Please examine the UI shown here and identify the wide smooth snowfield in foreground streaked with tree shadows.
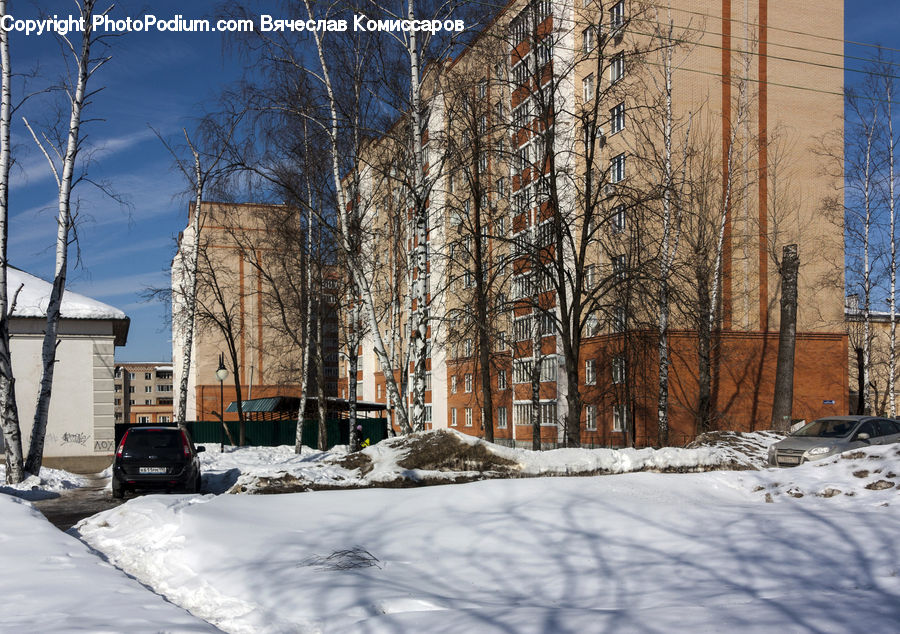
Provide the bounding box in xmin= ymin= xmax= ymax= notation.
xmin=73 ymin=445 xmax=900 ymax=633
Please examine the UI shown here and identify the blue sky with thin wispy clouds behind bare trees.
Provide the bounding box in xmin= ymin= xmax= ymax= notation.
xmin=10 ymin=0 xmax=900 ymax=361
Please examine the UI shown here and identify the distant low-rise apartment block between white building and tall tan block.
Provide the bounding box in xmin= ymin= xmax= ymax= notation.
xmin=113 ymin=361 xmax=174 ymax=423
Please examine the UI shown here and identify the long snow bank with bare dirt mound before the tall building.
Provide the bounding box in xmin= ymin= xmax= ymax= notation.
xmin=201 ymin=430 xmax=780 ymax=493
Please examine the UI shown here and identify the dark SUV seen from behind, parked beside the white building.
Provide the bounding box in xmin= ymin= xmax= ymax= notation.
xmin=112 ymin=425 xmax=206 ymax=498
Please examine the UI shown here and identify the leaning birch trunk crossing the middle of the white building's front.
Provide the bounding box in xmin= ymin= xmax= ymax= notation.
xmin=25 ymin=0 xmax=102 ymax=475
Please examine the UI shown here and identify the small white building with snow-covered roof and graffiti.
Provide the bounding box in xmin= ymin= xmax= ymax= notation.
xmin=0 ymin=268 xmax=129 ymax=471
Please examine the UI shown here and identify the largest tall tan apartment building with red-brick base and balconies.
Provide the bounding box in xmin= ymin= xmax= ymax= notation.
xmin=339 ymin=0 xmax=848 ymax=446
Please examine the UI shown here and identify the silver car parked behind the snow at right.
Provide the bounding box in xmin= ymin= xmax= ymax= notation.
xmin=769 ymin=416 xmax=900 ymax=467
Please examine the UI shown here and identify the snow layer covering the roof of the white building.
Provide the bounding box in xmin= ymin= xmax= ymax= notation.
xmin=6 ymin=267 xmax=126 ymax=319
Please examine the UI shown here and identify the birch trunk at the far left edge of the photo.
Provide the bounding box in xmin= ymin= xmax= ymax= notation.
xmin=0 ymin=0 xmax=25 ymax=484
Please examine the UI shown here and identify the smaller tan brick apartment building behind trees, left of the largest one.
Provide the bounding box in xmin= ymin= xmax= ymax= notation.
xmin=172 ymin=202 xmax=338 ymax=420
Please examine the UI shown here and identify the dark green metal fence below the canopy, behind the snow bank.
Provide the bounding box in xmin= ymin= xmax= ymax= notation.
xmin=187 ymin=418 xmax=387 ymax=449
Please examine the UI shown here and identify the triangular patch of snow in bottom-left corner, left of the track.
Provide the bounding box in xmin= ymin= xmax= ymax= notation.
xmin=0 ymin=495 xmax=213 ymax=634
